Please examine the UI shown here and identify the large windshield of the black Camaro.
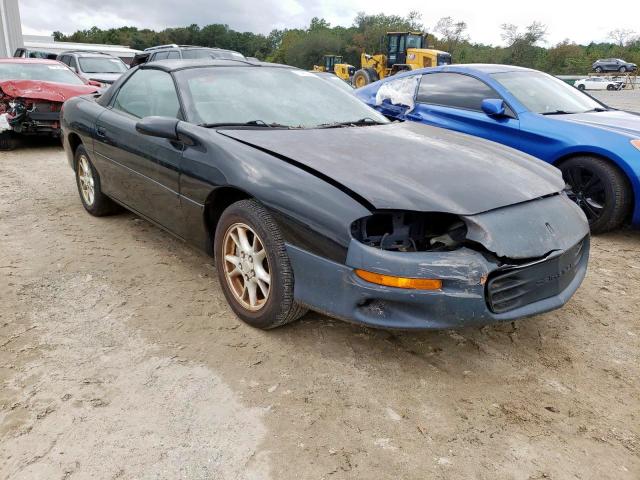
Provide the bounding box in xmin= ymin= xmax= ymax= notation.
xmin=175 ymin=67 xmax=388 ymax=128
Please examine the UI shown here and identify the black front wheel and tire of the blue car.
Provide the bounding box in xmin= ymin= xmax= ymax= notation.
xmin=560 ymin=156 xmax=632 ymax=234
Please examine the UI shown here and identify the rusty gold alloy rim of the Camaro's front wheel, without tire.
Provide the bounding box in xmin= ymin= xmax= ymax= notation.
xmin=222 ymin=223 xmax=271 ymax=312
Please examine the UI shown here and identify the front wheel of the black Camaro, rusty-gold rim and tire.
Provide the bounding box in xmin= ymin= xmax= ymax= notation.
xmin=214 ymin=200 xmax=306 ymax=330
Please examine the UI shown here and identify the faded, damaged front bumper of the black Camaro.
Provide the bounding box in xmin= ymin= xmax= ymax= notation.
xmin=287 ymin=196 xmax=589 ymax=329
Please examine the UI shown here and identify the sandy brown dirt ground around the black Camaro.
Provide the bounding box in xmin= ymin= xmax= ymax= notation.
xmin=0 ymin=92 xmax=640 ymax=480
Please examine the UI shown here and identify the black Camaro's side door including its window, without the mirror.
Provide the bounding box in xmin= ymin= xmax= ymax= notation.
xmin=94 ymin=68 xmax=183 ymax=235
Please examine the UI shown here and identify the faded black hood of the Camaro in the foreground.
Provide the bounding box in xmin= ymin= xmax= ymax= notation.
xmin=218 ymin=122 xmax=564 ymax=215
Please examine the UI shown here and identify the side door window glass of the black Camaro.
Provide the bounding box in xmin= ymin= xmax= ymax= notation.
xmin=113 ymin=69 xmax=181 ymax=118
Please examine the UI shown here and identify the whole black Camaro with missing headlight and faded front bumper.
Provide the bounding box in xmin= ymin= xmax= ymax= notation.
xmin=62 ymin=60 xmax=589 ymax=329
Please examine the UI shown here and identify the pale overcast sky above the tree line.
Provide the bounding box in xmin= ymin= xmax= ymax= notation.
xmin=19 ymin=0 xmax=640 ymax=45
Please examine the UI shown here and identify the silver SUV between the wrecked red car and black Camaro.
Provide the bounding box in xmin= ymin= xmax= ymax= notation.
xmin=57 ymin=50 xmax=129 ymax=85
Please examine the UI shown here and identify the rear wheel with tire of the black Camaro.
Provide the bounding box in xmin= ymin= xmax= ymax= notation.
xmin=74 ymin=145 xmax=119 ymax=217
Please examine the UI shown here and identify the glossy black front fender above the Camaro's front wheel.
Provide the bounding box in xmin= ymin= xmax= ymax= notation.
xmin=180 ymin=124 xmax=370 ymax=263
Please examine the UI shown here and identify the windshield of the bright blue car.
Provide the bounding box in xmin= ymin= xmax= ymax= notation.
xmin=492 ymin=71 xmax=603 ymax=114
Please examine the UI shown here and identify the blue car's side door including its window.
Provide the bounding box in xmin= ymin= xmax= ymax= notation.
xmin=406 ymin=72 xmax=521 ymax=148
